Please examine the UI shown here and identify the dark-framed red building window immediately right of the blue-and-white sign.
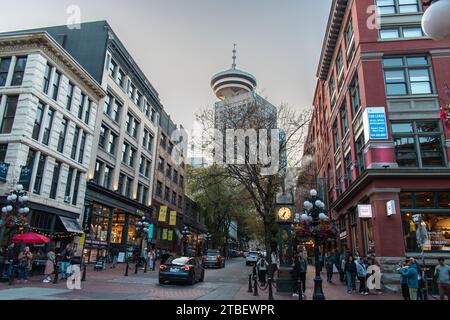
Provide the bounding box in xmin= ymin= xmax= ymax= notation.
xmin=392 ymin=121 xmax=445 ymax=167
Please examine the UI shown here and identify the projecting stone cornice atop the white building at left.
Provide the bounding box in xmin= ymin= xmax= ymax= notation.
xmin=0 ymin=32 xmax=106 ymax=101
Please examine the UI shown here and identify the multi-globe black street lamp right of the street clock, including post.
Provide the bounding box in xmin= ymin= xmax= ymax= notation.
xmin=301 ymin=189 xmax=330 ymax=300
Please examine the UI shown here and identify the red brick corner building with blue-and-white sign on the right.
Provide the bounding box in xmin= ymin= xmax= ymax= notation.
xmin=300 ymin=0 xmax=450 ymax=290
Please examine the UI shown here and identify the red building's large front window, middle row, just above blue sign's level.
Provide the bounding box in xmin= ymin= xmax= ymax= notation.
xmin=383 ymin=56 xmax=433 ymax=96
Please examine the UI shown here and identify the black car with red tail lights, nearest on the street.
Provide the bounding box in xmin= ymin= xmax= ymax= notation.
xmin=159 ymin=257 xmax=205 ymax=285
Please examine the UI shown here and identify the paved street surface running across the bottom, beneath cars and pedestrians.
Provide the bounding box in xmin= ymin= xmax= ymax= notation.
xmin=0 ymin=258 xmax=408 ymax=300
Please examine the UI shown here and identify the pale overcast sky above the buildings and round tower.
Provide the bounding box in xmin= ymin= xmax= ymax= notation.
xmin=0 ymin=0 xmax=331 ymax=129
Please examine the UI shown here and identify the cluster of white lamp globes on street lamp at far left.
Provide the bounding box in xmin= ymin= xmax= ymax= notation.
xmin=1 ymin=184 xmax=30 ymax=242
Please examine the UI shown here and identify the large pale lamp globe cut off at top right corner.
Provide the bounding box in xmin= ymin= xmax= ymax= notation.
xmin=422 ymin=0 xmax=450 ymax=40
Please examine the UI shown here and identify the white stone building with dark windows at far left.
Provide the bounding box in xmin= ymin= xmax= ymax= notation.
xmin=0 ymin=32 xmax=105 ymax=251
